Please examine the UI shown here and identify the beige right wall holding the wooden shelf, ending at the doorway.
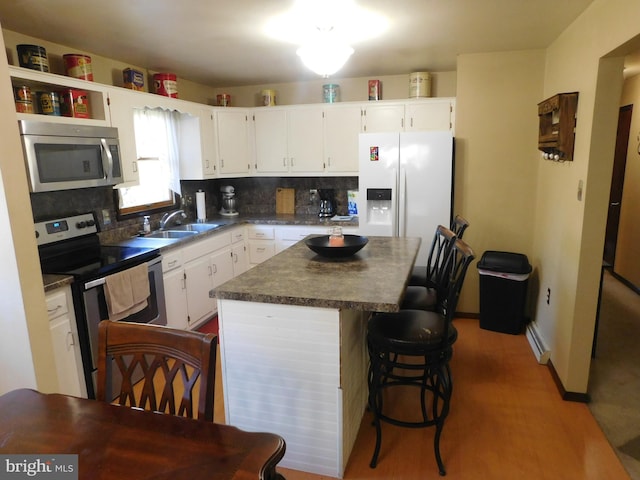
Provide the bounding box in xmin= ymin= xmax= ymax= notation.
xmin=534 ymin=0 xmax=640 ymax=392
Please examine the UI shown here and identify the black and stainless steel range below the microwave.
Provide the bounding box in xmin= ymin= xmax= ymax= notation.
xmin=35 ymin=213 xmax=167 ymax=398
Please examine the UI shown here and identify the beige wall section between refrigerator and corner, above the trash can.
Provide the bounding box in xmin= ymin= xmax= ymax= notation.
xmin=455 ymin=50 xmax=545 ymax=312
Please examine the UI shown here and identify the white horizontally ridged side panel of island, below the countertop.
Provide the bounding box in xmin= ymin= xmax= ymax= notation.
xmin=218 ymin=299 xmax=350 ymax=478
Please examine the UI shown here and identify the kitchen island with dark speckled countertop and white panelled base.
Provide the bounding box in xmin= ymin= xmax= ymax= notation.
xmin=215 ymin=237 xmax=420 ymax=478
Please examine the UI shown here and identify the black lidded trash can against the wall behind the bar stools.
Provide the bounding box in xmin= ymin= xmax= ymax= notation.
xmin=477 ymin=250 xmax=531 ymax=335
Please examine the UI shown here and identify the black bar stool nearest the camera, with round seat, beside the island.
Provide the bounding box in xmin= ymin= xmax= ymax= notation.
xmin=367 ymin=240 xmax=474 ymax=475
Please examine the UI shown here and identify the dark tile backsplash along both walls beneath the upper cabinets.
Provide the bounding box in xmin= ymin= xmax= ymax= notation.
xmin=31 ymin=177 xmax=358 ymax=241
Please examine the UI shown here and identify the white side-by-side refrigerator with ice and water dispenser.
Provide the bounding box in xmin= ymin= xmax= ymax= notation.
xmin=358 ymin=131 xmax=453 ymax=265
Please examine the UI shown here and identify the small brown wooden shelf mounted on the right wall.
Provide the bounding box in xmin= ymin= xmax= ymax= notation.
xmin=538 ymin=92 xmax=578 ymax=162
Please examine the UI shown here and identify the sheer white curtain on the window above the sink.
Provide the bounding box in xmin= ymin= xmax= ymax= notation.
xmin=134 ymin=108 xmax=182 ymax=194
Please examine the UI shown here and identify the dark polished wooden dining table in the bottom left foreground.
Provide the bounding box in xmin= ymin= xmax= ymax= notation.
xmin=0 ymin=389 xmax=285 ymax=480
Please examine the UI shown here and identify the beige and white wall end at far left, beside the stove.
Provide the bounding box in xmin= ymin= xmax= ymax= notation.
xmin=0 ymin=25 xmax=58 ymax=394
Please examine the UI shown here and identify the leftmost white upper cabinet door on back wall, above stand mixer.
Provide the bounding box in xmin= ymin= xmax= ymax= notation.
xmin=215 ymin=108 xmax=251 ymax=176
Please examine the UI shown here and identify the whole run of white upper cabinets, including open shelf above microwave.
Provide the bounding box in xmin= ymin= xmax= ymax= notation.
xmin=9 ymin=66 xmax=455 ymax=182
